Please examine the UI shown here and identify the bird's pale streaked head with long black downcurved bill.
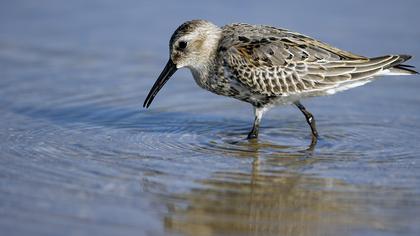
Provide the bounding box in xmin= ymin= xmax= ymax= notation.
xmin=143 ymin=20 xmax=221 ymax=108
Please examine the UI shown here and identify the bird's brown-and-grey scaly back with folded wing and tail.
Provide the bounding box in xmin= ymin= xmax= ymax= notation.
xmin=218 ymin=24 xmax=416 ymax=106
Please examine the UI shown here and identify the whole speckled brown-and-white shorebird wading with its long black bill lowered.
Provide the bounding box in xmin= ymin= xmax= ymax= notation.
xmin=143 ymin=20 xmax=418 ymax=144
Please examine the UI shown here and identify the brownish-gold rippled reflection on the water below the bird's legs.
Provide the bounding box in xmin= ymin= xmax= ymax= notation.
xmin=164 ymin=138 xmax=386 ymax=235
